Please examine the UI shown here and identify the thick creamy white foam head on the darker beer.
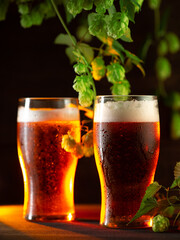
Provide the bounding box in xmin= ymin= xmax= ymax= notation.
xmin=94 ymin=100 xmax=159 ymax=122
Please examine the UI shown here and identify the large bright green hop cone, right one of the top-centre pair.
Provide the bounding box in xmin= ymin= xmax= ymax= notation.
xmin=106 ymin=12 xmax=129 ymax=39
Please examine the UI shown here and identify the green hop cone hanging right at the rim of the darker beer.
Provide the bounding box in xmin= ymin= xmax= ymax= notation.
xmin=111 ymin=80 xmax=131 ymax=95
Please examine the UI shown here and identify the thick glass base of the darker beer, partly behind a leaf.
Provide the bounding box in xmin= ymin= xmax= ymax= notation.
xmin=101 ymin=216 xmax=151 ymax=229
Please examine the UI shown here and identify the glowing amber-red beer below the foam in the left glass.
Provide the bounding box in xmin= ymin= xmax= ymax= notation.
xmin=17 ymin=121 xmax=80 ymax=221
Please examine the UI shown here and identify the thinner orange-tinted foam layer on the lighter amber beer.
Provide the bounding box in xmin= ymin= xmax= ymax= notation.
xmin=17 ymin=107 xmax=79 ymax=122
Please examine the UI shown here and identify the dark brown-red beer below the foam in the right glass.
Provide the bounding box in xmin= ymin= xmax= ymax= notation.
xmin=94 ymin=122 xmax=160 ymax=227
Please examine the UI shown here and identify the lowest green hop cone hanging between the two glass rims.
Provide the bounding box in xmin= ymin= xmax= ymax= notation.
xmin=78 ymin=88 xmax=94 ymax=107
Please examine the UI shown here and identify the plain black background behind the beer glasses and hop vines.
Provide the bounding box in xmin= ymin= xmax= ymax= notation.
xmin=0 ymin=0 xmax=180 ymax=204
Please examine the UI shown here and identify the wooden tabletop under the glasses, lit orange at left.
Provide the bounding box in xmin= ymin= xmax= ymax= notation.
xmin=0 ymin=205 xmax=180 ymax=240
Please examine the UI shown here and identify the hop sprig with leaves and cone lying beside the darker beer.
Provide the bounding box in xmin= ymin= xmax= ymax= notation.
xmin=129 ymin=165 xmax=180 ymax=232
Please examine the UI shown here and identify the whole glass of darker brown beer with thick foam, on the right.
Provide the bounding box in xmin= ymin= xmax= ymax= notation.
xmin=94 ymin=96 xmax=160 ymax=228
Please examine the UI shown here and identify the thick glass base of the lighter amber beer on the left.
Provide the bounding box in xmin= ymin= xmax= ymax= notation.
xmin=24 ymin=213 xmax=75 ymax=222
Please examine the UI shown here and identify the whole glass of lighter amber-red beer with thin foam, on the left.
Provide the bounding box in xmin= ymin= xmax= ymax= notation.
xmin=17 ymin=98 xmax=80 ymax=222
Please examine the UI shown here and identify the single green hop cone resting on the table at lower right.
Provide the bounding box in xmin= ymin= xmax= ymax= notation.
xmin=152 ymin=214 xmax=170 ymax=232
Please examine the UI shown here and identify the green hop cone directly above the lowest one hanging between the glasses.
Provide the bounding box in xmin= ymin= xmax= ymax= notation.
xmin=73 ymin=75 xmax=91 ymax=92
